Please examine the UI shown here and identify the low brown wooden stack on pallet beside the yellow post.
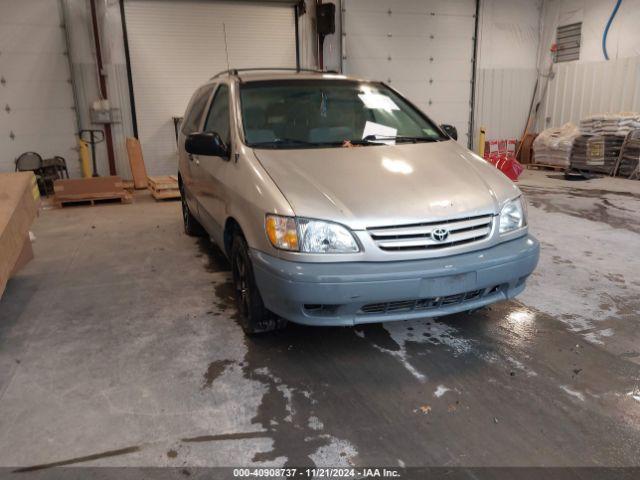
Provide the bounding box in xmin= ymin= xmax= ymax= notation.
xmin=53 ymin=176 xmax=131 ymax=207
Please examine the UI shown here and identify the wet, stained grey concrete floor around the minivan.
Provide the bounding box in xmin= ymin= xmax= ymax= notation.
xmin=0 ymin=172 xmax=640 ymax=467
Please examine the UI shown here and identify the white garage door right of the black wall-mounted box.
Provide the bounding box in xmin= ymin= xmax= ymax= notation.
xmin=343 ymin=0 xmax=475 ymax=145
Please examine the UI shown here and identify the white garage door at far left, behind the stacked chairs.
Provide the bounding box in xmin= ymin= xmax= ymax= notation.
xmin=0 ymin=0 xmax=79 ymax=174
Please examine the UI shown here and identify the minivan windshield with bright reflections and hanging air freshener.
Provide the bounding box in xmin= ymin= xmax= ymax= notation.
xmin=240 ymin=80 xmax=447 ymax=148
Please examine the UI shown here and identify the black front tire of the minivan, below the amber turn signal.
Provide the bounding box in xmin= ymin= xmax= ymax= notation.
xmin=231 ymin=232 xmax=285 ymax=335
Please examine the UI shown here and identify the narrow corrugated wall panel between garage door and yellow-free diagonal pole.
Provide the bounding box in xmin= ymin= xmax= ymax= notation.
xmin=473 ymin=68 xmax=537 ymax=149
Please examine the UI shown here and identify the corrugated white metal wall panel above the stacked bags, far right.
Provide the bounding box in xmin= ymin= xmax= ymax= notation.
xmin=538 ymin=57 xmax=640 ymax=130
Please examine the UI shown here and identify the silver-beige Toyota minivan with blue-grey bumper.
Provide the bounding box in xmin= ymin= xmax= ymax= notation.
xmin=178 ymin=69 xmax=539 ymax=334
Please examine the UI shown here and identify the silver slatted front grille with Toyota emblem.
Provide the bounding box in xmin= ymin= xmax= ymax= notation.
xmin=367 ymin=215 xmax=493 ymax=251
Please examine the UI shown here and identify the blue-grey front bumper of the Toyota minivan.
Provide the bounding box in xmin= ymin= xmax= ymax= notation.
xmin=251 ymin=235 xmax=540 ymax=326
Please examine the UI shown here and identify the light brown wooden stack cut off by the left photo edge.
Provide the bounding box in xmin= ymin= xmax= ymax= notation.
xmin=0 ymin=172 xmax=40 ymax=297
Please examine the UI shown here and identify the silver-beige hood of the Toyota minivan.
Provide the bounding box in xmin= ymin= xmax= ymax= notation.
xmin=254 ymin=141 xmax=519 ymax=230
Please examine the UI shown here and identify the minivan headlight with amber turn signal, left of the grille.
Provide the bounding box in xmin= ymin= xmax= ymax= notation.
xmin=265 ymin=215 xmax=360 ymax=253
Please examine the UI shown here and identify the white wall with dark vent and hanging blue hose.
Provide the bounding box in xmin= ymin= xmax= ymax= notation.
xmin=537 ymin=0 xmax=640 ymax=130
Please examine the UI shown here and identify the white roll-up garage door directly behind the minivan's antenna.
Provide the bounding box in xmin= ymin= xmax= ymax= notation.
xmin=125 ymin=0 xmax=296 ymax=175
